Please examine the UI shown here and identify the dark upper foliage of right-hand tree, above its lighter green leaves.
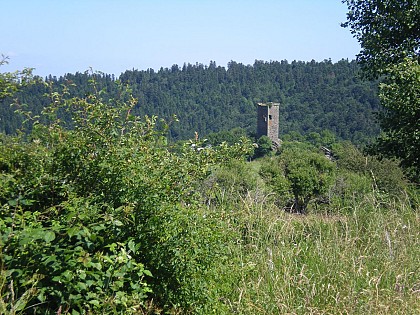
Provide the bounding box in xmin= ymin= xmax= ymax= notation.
xmin=343 ymin=0 xmax=420 ymax=77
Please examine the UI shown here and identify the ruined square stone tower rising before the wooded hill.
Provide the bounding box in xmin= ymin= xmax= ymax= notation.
xmin=257 ymin=102 xmax=280 ymax=145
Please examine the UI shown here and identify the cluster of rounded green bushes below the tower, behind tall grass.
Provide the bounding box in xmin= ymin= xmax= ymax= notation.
xmin=256 ymin=141 xmax=408 ymax=215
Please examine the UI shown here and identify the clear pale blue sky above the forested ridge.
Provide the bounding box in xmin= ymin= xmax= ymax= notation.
xmin=0 ymin=0 xmax=360 ymax=77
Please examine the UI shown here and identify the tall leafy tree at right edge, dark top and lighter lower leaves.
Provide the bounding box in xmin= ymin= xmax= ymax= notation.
xmin=343 ymin=0 xmax=420 ymax=182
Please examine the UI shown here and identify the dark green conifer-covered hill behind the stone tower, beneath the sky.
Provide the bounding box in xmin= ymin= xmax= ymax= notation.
xmin=0 ymin=60 xmax=379 ymax=143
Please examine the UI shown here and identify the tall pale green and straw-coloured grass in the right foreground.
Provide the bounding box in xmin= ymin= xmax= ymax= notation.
xmin=220 ymin=193 xmax=420 ymax=314
